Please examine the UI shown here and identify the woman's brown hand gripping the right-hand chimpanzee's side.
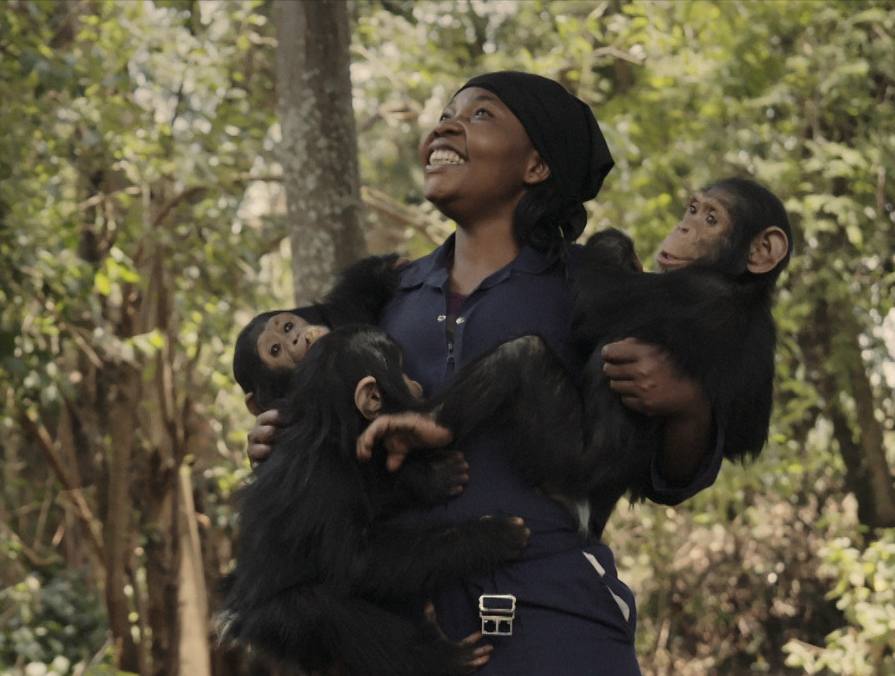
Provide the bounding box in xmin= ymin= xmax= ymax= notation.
xmin=601 ymin=338 xmax=708 ymax=416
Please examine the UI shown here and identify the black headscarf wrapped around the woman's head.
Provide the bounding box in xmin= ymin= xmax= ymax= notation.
xmin=458 ymin=70 xmax=615 ymax=204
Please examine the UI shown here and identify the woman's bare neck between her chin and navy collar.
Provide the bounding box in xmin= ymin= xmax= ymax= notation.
xmin=450 ymin=221 xmax=519 ymax=296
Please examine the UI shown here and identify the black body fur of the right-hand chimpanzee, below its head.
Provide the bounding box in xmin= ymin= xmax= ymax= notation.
xmin=574 ymin=223 xmax=788 ymax=533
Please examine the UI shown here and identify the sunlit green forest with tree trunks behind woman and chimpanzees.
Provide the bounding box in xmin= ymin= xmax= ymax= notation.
xmin=0 ymin=0 xmax=895 ymax=676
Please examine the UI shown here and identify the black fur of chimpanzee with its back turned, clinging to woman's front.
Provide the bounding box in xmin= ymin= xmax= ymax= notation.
xmin=224 ymin=327 xmax=527 ymax=676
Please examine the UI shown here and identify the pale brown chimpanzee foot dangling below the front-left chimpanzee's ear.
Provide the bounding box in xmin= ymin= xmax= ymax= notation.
xmin=357 ymin=413 xmax=454 ymax=472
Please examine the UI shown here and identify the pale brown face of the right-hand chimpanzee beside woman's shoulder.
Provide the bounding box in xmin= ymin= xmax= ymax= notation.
xmin=656 ymin=192 xmax=733 ymax=272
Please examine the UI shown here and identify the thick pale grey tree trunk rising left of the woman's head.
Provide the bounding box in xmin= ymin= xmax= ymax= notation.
xmin=274 ymin=0 xmax=366 ymax=305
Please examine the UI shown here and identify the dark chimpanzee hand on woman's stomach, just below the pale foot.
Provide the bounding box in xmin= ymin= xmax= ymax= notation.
xmin=397 ymin=451 xmax=469 ymax=505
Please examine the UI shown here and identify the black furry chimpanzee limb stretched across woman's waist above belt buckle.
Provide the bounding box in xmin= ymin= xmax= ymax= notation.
xmin=353 ymin=516 xmax=529 ymax=600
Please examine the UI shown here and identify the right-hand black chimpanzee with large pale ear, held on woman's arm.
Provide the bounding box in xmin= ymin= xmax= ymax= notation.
xmin=575 ymin=178 xmax=792 ymax=533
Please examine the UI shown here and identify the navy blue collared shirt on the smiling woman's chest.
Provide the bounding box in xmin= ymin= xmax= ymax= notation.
xmin=380 ymin=235 xmax=723 ymax=505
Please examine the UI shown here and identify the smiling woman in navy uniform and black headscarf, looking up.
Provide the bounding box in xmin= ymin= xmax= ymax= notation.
xmin=250 ymin=72 xmax=721 ymax=676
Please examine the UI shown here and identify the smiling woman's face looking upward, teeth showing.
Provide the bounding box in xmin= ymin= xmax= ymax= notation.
xmin=420 ymin=87 xmax=546 ymax=220
